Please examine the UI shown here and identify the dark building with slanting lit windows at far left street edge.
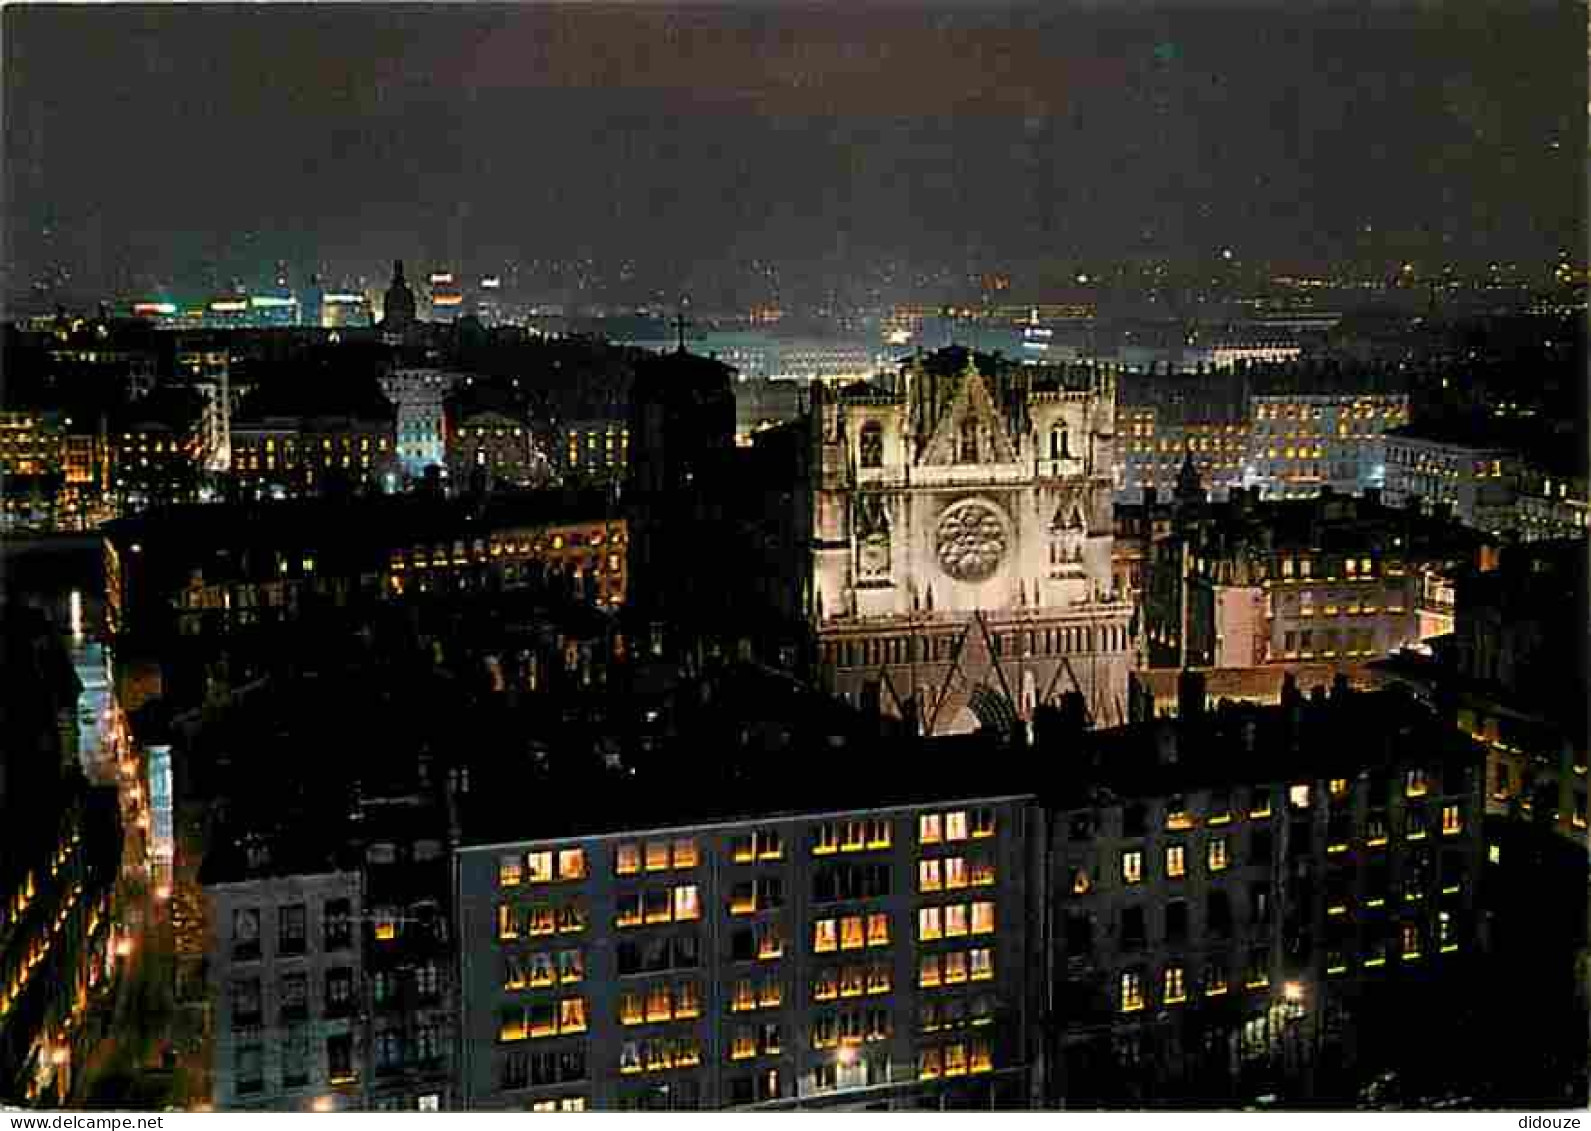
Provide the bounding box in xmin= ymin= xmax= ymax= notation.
xmin=0 ymin=603 xmax=121 ymax=1107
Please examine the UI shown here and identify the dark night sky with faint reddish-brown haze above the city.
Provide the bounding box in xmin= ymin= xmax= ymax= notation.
xmin=3 ymin=0 xmax=1588 ymax=299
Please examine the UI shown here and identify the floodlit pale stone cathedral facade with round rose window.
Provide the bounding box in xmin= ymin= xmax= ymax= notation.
xmin=802 ymin=350 xmax=1133 ymax=733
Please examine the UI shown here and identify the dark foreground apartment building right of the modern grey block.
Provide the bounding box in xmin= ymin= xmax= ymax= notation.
xmin=1039 ymin=673 xmax=1484 ymax=1107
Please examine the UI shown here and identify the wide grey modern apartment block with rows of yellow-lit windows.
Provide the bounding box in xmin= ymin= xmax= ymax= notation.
xmin=455 ymin=740 xmax=1041 ymax=1112
